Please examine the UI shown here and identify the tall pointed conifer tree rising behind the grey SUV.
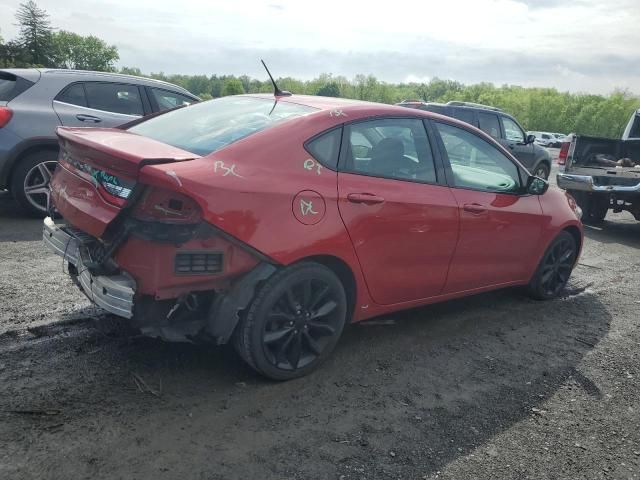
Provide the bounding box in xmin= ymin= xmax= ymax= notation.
xmin=16 ymin=0 xmax=52 ymax=66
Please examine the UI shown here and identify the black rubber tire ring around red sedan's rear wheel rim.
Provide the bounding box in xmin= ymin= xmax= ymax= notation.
xmin=243 ymin=262 xmax=347 ymax=380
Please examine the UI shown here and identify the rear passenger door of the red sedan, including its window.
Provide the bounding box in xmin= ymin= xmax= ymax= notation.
xmin=338 ymin=118 xmax=458 ymax=305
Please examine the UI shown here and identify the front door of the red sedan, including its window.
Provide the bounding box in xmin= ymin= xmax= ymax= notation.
xmin=434 ymin=121 xmax=543 ymax=293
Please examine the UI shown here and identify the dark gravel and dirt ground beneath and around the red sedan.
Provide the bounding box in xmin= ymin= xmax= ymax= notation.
xmin=0 ymin=173 xmax=640 ymax=480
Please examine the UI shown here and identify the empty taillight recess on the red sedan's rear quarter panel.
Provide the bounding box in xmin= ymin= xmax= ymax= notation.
xmin=133 ymin=187 xmax=202 ymax=224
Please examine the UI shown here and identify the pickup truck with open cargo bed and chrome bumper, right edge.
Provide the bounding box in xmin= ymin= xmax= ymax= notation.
xmin=557 ymin=109 xmax=640 ymax=223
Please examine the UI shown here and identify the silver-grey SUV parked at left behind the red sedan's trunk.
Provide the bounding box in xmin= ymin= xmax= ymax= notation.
xmin=0 ymin=68 xmax=199 ymax=215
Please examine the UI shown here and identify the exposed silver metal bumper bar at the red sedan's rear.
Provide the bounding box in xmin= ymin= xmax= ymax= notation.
xmin=42 ymin=217 xmax=136 ymax=318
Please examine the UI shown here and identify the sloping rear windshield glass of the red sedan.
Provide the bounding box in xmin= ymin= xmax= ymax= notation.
xmin=129 ymin=97 xmax=317 ymax=156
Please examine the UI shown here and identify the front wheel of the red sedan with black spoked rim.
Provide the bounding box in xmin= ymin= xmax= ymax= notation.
xmin=528 ymin=231 xmax=578 ymax=300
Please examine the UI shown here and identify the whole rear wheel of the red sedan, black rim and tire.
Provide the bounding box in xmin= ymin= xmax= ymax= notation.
xmin=234 ymin=262 xmax=347 ymax=380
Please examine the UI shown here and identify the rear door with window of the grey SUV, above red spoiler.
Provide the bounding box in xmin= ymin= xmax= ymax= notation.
xmin=53 ymin=82 xmax=145 ymax=127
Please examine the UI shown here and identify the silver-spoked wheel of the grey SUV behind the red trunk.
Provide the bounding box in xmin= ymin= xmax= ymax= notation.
xmin=11 ymin=150 xmax=58 ymax=217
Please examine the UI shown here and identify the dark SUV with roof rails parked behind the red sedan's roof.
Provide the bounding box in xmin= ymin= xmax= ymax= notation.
xmin=397 ymin=100 xmax=551 ymax=179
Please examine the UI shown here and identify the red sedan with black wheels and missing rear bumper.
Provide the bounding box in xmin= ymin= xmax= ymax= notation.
xmin=43 ymin=95 xmax=583 ymax=380
